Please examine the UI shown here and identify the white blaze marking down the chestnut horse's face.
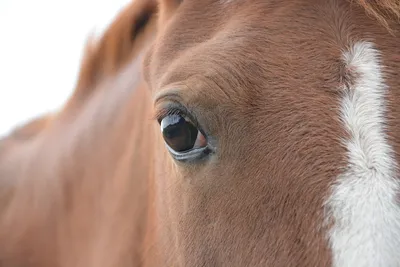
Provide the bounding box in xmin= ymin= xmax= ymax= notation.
xmin=326 ymin=42 xmax=400 ymax=267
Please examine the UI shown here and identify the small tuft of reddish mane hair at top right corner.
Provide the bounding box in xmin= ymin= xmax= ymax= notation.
xmin=354 ymin=0 xmax=400 ymax=32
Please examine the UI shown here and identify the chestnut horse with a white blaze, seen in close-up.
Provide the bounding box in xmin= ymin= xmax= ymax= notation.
xmin=0 ymin=0 xmax=400 ymax=267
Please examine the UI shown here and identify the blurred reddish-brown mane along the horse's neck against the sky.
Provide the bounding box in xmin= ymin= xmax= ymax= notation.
xmin=71 ymin=0 xmax=158 ymax=104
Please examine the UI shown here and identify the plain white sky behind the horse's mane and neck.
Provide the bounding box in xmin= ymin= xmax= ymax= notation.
xmin=0 ymin=0 xmax=130 ymax=136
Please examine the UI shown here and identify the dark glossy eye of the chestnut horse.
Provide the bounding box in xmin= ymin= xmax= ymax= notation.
xmin=161 ymin=114 xmax=207 ymax=153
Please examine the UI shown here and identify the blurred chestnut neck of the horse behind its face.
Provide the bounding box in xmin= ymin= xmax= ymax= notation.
xmin=0 ymin=57 xmax=159 ymax=267
